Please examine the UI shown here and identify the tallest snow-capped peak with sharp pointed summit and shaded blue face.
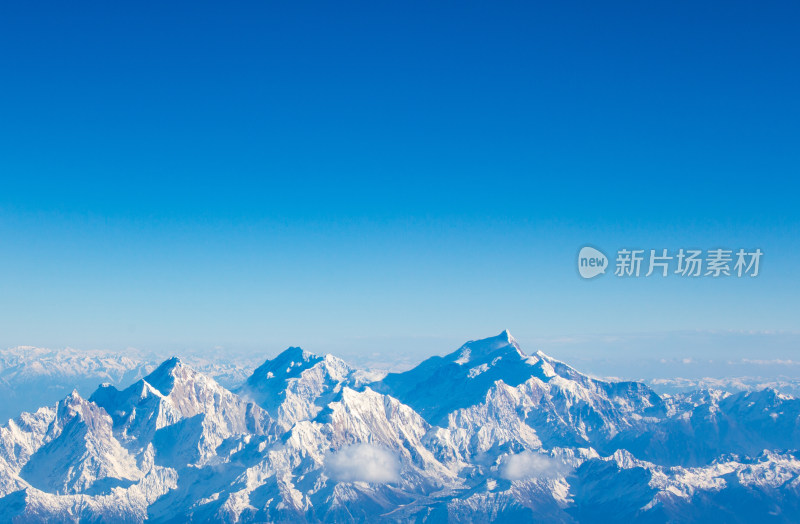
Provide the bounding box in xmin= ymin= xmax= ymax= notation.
xmin=372 ymin=331 xmax=666 ymax=446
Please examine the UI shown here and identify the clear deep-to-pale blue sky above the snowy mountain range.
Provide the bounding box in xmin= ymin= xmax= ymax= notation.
xmin=0 ymin=2 xmax=800 ymax=374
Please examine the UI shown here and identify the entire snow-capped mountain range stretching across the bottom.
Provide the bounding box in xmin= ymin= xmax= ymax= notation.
xmin=0 ymin=332 xmax=800 ymax=522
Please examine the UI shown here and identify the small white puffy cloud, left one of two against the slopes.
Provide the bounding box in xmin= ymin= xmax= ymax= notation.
xmin=325 ymin=444 xmax=400 ymax=484
